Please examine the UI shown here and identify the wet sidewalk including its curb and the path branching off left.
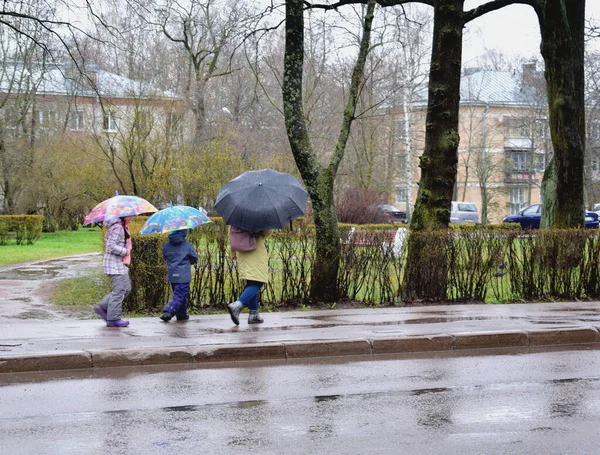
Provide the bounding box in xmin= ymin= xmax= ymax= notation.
xmin=0 ymin=255 xmax=600 ymax=372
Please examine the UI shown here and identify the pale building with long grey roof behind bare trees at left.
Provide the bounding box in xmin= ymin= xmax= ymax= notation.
xmin=0 ymin=62 xmax=186 ymax=145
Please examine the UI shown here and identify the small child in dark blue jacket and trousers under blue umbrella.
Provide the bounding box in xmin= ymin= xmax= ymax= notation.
xmin=160 ymin=229 xmax=198 ymax=322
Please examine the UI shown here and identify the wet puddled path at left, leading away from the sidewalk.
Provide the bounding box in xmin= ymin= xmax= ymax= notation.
xmin=0 ymin=253 xmax=102 ymax=320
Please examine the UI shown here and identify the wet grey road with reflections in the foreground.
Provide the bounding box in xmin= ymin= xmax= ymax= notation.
xmin=0 ymin=346 xmax=600 ymax=455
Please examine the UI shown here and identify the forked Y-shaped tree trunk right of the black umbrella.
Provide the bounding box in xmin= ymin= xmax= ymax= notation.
xmin=283 ymin=0 xmax=375 ymax=302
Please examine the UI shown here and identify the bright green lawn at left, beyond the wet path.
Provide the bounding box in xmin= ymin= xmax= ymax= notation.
xmin=0 ymin=228 xmax=102 ymax=266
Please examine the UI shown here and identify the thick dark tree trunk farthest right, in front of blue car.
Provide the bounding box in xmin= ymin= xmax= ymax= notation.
xmin=537 ymin=0 xmax=585 ymax=228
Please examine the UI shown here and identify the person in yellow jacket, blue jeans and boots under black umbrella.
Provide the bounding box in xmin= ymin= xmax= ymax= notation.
xmin=227 ymin=231 xmax=270 ymax=325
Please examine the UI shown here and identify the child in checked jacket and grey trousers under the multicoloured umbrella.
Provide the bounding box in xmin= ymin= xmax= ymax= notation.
xmin=94 ymin=216 xmax=131 ymax=327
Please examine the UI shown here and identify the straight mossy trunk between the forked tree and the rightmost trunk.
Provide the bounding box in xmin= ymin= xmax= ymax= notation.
xmin=405 ymin=0 xmax=464 ymax=300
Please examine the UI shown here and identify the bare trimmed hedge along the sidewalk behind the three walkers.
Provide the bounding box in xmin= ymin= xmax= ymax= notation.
xmin=126 ymin=219 xmax=600 ymax=311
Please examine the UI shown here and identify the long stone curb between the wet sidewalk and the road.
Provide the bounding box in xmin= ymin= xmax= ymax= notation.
xmin=0 ymin=327 xmax=600 ymax=374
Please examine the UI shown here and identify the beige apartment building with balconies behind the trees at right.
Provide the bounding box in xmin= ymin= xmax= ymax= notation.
xmin=388 ymin=63 xmax=551 ymax=223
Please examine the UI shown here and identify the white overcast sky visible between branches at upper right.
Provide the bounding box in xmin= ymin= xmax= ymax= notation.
xmin=463 ymin=0 xmax=600 ymax=65
